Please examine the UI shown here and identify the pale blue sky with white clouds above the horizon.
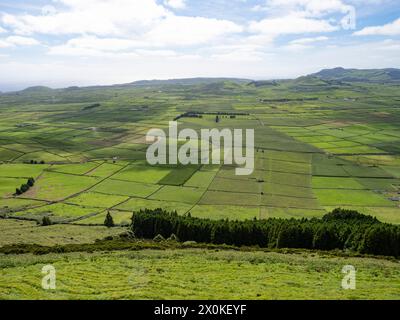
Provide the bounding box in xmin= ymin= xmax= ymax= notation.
xmin=0 ymin=0 xmax=400 ymax=91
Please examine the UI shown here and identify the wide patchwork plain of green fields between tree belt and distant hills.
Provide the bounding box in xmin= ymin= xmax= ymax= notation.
xmin=0 ymin=80 xmax=400 ymax=226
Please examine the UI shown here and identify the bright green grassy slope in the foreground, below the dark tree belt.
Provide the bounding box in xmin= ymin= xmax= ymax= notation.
xmin=0 ymin=249 xmax=400 ymax=299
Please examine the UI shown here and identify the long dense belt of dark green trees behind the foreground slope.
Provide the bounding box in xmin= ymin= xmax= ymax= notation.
xmin=132 ymin=209 xmax=400 ymax=256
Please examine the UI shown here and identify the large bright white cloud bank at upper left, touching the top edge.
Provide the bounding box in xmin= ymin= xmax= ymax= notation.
xmin=1 ymin=0 xmax=243 ymax=54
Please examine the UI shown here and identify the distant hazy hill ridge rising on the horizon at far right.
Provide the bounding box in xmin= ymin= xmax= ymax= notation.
xmin=308 ymin=67 xmax=400 ymax=82
